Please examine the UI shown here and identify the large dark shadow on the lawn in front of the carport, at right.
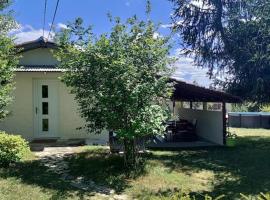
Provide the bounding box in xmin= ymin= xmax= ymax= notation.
xmin=144 ymin=137 xmax=270 ymax=199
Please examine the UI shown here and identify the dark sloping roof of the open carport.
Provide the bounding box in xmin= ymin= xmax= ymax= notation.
xmin=171 ymin=79 xmax=242 ymax=103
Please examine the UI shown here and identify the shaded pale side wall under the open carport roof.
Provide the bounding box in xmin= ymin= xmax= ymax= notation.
xmin=177 ymin=107 xmax=223 ymax=145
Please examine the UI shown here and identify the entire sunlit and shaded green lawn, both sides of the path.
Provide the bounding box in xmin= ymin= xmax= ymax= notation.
xmin=0 ymin=129 xmax=270 ymax=199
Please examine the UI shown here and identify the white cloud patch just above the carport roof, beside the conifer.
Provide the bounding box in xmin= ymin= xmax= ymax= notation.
xmin=172 ymin=49 xmax=212 ymax=87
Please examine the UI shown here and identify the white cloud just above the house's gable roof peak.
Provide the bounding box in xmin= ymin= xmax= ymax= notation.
xmin=10 ymin=24 xmax=55 ymax=44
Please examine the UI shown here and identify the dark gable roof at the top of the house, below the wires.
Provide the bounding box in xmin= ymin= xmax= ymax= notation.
xmin=16 ymin=37 xmax=57 ymax=53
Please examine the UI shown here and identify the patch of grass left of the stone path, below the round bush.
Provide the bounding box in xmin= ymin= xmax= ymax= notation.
xmin=0 ymin=154 xmax=92 ymax=200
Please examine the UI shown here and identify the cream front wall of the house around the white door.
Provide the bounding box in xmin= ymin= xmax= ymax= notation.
xmin=0 ymin=72 xmax=108 ymax=143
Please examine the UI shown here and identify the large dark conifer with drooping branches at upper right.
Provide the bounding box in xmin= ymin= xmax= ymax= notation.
xmin=172 ymin=0 xmax=270 ymax=104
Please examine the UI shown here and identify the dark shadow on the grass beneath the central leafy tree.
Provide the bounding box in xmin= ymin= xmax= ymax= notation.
xmin=64 ymin=148 xmax=146 ymax=193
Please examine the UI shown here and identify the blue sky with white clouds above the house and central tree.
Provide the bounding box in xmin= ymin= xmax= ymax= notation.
xmin=8 ymin=0 xmax=212 ymax=86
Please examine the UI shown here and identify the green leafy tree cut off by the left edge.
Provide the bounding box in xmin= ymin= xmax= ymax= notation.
xmin=0 ymin=2 xmax=18 ymax=119
